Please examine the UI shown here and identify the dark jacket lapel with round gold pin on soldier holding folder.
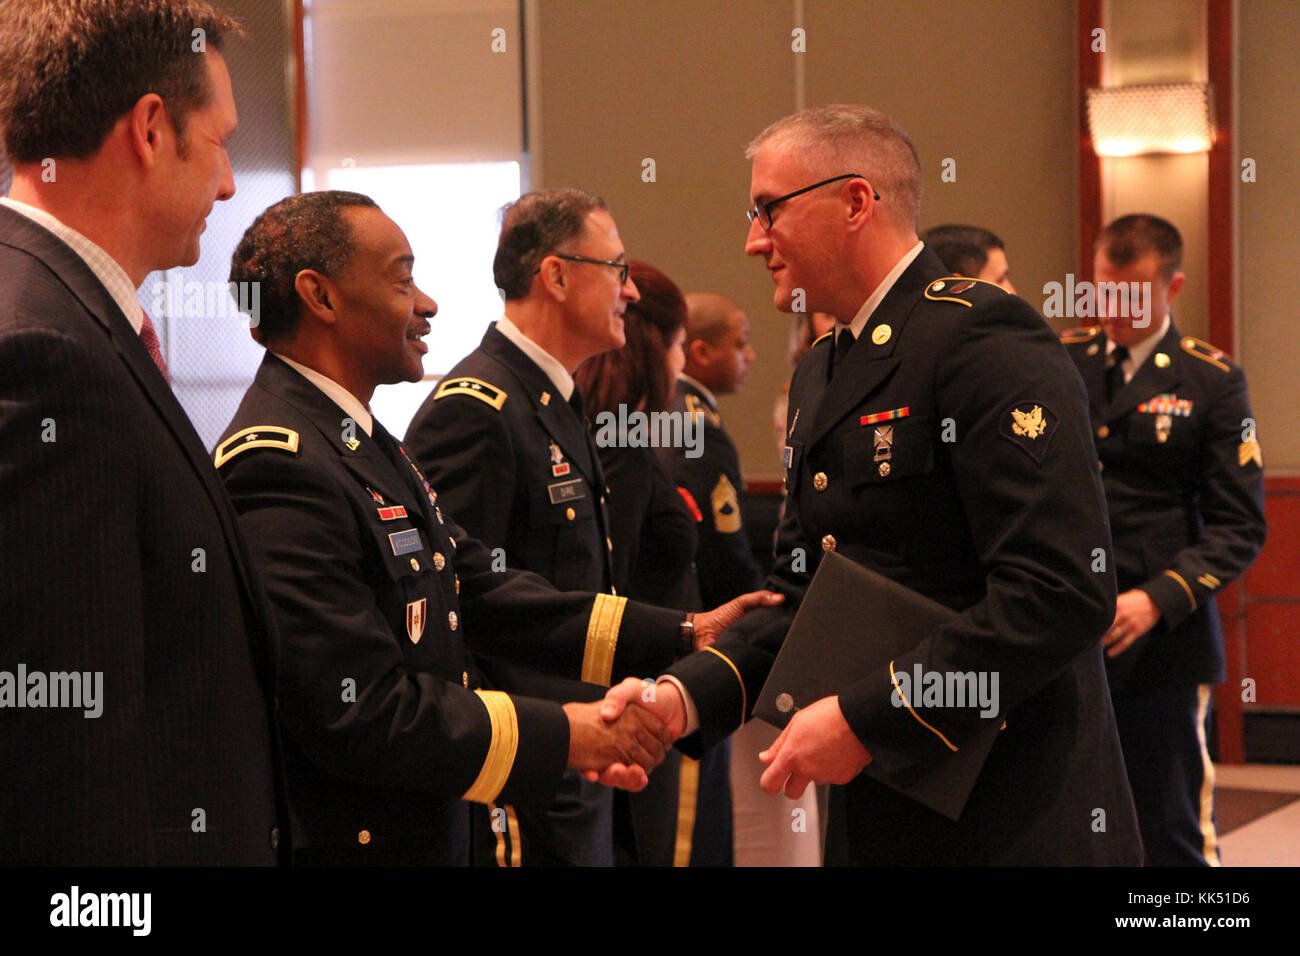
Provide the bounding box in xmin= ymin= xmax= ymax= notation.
xmin=809 ymin=248 xmax=948 ymax=446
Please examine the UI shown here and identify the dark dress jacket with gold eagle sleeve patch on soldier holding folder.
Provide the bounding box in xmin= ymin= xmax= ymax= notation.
xmin=671 ymin=250 xmax=1141 ymax=865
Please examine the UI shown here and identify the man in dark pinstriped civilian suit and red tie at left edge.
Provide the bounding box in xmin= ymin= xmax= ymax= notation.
xmin=0 ymin=0 xmax=287 ymax=865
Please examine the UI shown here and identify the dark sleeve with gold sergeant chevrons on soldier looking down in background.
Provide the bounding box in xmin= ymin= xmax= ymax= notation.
xmin=1138 ymin=365 xmax=1268 ymax=627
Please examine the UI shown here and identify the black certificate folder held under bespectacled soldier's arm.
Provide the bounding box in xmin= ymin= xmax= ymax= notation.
xmin=754 ymin=551 xmax=1002 ymax=819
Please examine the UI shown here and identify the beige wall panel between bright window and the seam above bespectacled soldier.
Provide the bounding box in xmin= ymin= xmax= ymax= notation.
xmin=530 ymin=0 xmax=797 ymax=477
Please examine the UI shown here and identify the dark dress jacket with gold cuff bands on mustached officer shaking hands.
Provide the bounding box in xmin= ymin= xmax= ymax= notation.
xmin=216 ymin=354 xmax=675 ymax=864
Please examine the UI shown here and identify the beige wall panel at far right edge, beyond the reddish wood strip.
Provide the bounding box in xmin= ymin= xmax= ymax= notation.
xmin=1235 ymin=0 xmax=1300 ymax=473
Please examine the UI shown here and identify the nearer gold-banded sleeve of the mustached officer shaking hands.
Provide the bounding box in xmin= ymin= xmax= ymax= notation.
xmin=222 ymin=451 xmax=568 ymax=803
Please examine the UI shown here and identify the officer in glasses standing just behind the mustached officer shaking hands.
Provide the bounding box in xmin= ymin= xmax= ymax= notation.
xmin=406 ymin=190 xmax=655 ymax=866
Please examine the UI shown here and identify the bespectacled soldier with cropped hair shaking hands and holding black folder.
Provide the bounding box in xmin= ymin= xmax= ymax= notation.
xmin=607 ymin=105 xmax=1140 ymax=865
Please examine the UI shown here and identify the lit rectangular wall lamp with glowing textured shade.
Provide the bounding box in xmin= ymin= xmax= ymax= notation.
xmin=1086 ymin=83 xmax=1214 ymax=156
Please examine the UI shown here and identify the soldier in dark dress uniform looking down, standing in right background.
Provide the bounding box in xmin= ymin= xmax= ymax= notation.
xmin=1062 ymin=215 xmax=1266 ymax=866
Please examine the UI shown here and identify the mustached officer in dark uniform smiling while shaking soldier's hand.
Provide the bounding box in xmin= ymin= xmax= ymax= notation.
xmin=216 ymin=193 xmax=680 ymax=864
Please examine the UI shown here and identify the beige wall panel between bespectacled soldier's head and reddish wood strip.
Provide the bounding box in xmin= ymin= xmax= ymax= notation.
xmin=806 ymin=0 xmax=1078 ymax=328
